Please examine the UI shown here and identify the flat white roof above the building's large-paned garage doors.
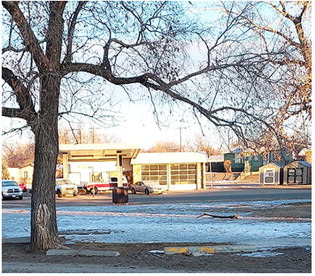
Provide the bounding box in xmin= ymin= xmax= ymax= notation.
xmin=131 ymin=152 xmax=209 ymax=165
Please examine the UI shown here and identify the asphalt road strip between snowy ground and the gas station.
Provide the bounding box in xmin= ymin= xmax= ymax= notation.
xmin=2 ymin=184 xmax=312 ymax=208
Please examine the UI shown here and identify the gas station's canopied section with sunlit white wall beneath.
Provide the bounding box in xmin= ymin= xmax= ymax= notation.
xmin=57 ymin=143 xmax=140 ymax=184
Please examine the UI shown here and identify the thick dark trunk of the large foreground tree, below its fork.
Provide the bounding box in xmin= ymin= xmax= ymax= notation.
xmin=30 ymin=75 xmax=62 ymax=251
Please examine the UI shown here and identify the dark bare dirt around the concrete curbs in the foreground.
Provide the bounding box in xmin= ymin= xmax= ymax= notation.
xmin=2 ymin=243 xmax=311 ymax=273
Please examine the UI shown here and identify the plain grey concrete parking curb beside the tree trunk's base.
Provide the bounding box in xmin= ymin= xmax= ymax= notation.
xmin=46 ymin=249 xmax=120 ymax=257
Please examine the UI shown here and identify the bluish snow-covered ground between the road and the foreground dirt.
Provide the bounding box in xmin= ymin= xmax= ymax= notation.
xmin=2 ymin=200 xmax=311 ymax=250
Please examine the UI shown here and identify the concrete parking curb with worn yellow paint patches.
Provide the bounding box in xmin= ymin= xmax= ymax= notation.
xmin=164 ymin=244 xmax=258 ymax=255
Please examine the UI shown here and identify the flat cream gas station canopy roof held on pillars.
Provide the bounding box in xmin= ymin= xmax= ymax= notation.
xmin=59 ymin=143 xmax=141 ymax=162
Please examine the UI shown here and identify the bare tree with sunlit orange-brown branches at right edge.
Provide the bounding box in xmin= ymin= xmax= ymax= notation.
xmin=223 ymin=1 xmax=312 ymax=151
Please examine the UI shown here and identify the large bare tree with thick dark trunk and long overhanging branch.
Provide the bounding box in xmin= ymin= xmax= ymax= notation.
xmin=2 ymin=1 xmax=310 ymax=250
